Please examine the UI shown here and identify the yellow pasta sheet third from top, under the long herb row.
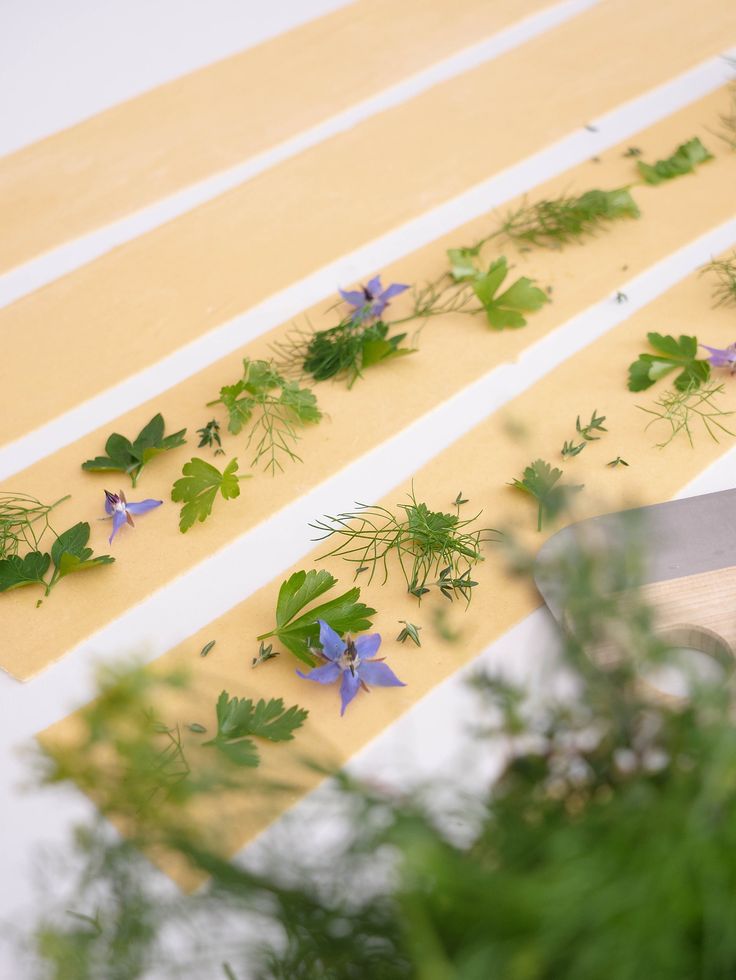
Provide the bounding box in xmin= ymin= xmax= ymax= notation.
xmin=0 ymin=92 xmax=736 ymax=679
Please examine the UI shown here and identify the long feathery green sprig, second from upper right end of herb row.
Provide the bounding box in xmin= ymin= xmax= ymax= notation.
xmin=499 ymin=187 xmax=640 ymax=248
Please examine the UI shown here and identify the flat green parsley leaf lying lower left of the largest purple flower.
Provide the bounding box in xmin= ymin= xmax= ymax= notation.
xmin=202 ymin=691 xmax=309 ymax=767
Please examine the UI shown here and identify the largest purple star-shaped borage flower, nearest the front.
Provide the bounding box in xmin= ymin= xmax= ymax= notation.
xmin=297 ymin=619 xmax=406 ymax=715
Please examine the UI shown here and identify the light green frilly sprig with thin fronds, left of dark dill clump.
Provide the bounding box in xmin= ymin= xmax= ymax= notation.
xmin=207 ymin=357 xmax=322 ymax=474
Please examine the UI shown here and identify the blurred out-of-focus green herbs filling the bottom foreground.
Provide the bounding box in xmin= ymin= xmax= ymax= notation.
xmin=25 ymin=516 xmax=736 ymax=980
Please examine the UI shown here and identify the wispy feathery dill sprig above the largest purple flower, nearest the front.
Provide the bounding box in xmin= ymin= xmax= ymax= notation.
xmin=310 ymin=489 xmax=497 ymax=602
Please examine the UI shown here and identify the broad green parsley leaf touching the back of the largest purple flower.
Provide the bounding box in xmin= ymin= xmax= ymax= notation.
xmin=256 ymin=569 xmax=376 ymax=667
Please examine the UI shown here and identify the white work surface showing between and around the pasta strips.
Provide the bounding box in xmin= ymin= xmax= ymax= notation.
xmin=0 ymin=0 xmax=736 ymax=980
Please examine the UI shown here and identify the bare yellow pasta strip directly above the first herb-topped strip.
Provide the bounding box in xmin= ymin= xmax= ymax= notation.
xmin=0 ymin=0 xmax=736 ymax=442
